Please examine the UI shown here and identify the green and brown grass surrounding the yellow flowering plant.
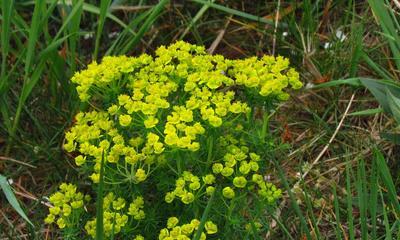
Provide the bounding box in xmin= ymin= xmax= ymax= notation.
xmin=0 ymin=0 xmax=400 ymax=239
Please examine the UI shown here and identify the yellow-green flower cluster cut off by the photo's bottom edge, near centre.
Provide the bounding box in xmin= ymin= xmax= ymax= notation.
xmin=158 ymin=217 xmax=218 ymax=240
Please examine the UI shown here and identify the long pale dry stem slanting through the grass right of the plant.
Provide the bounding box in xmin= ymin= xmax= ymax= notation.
xmin=267 ymin=93 xmax=356 ymax=232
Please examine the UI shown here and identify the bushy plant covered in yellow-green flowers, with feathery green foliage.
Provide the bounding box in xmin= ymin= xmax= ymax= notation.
xmin=45 ymin=42 xmax=302 ymax=239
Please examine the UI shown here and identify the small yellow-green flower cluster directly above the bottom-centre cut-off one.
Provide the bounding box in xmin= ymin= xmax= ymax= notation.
xmin=164 ymin=171 xmax=201 ymax=204
